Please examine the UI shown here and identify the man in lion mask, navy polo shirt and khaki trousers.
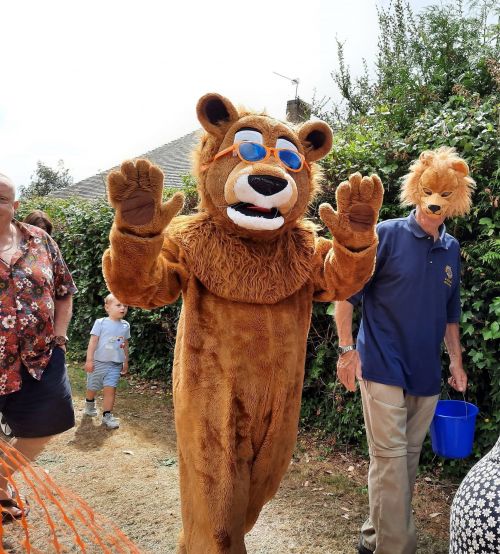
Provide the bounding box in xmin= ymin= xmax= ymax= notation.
xmin=335 ymin=148 xmax=473 ymax=554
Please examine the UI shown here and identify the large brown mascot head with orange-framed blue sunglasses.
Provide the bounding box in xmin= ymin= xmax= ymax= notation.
xmin=194 ymin=94 xmax=332 ymax=238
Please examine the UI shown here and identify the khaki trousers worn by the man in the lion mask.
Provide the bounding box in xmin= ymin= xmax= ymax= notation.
xmin=360 ymin=381 xmax=439 ymax=554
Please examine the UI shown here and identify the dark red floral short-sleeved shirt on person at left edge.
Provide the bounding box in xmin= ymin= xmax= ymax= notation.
xmin=0 ymin=221 xmax=76 ymax=395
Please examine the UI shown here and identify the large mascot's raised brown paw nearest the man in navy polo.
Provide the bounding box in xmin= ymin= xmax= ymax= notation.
xmin=319 ymin=173 xmax=384 ymax=249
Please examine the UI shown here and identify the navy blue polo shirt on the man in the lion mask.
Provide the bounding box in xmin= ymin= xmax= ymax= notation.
xmin=349 ymin=210 xmax=460 ymax=396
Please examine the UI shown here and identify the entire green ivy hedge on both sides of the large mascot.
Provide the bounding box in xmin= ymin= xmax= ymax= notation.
xmin=19 ymin=97 xmax=500 ymax=465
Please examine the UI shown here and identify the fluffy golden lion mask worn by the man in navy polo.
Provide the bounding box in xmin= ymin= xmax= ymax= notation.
xmin=401 ymin=146 xmax=475 ymax=218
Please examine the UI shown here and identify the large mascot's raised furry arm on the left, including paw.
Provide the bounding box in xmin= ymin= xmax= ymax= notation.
xmin=102 ymin=160 xmax=187 ymax=308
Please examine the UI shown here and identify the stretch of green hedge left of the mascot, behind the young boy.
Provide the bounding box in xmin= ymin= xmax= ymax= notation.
xmin=17 ymin=182 xmax=194 ymax=380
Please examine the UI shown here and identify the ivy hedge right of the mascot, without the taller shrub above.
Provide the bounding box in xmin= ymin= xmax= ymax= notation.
xmin=302 ymin=92 xmax=500 ymax=471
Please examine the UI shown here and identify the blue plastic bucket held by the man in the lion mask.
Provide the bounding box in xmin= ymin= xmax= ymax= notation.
xmin=431 ymin=400 xmax=479 ymax=458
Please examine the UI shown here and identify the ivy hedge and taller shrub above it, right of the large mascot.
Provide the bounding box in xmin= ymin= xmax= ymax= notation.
xmin=302 ymin=0 xmax=500 ymax=472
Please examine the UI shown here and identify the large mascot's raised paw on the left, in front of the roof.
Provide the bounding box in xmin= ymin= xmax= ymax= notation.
xmin=108 ymin=160 xmax=184 ymax=234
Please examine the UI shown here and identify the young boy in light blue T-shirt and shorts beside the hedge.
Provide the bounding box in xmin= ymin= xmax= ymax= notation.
xmin=84 ymin=294 xmax=130 ymax=429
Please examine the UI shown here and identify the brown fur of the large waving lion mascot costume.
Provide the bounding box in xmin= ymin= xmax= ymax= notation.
xmin=103 ymin=94 xmax=382 ymax=554
